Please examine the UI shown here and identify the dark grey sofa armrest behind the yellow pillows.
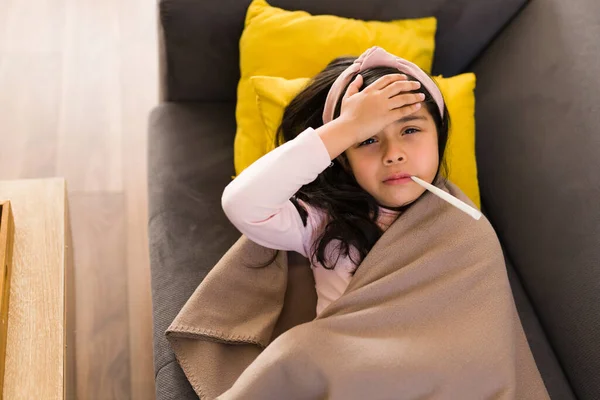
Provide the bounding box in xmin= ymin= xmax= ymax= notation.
xmin=159 ymin=0 xmax=526 ymax=101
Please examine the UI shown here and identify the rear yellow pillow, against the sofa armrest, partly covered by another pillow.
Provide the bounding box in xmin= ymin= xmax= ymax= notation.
xmin=234 ymin=0 xmax=437 ymax=174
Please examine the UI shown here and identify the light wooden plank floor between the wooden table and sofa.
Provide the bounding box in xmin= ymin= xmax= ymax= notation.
xmin=0 ymin=0 xmax=158 ymax=400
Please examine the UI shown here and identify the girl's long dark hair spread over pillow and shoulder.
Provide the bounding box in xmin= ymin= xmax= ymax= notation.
xmin=258 ymin=57 xmax=450 ymax=273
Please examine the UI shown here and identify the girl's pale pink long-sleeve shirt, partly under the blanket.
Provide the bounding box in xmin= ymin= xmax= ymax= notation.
xmin=221 ymin=128 xmax=398 ymax=315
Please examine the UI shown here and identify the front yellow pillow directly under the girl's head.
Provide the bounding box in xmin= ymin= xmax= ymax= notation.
xmin=250 ymin=73 xmax=480 ymax=208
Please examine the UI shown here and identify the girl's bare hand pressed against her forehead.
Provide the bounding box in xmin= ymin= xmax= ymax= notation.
xmin=338 ymin=74 xmax=425 ymax=143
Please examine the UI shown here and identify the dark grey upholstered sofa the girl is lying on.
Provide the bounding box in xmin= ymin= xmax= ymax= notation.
xmin=149 ymin=0 xmax=600 ymax=400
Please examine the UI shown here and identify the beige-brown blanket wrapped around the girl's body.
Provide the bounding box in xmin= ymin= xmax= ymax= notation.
xmin=167 ymin=181 xmax=549 ymax=400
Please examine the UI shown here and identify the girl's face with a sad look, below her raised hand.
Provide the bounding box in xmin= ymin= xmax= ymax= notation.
xmin=345 ymin=107 xmax=439 ymax=207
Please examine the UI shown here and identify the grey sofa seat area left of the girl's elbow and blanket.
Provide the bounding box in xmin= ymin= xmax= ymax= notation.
xmin=148 ymin=103 xmax=240 ymax=388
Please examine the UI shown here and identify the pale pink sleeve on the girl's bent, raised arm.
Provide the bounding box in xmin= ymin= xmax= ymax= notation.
xmin=221 ymin=128 xmax=331 ymax=257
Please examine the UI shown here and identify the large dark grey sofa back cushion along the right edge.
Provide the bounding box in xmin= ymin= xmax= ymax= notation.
xmin=473 ymin=0 xmax=600 ymax=399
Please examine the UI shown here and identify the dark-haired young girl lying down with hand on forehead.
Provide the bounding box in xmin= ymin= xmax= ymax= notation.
xmin=222 ymin=47 xmax=449 ymax=315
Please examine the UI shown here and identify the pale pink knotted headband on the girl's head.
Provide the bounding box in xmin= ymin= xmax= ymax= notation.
xmin=323 ymin=46 xmax=444 ymax=124
